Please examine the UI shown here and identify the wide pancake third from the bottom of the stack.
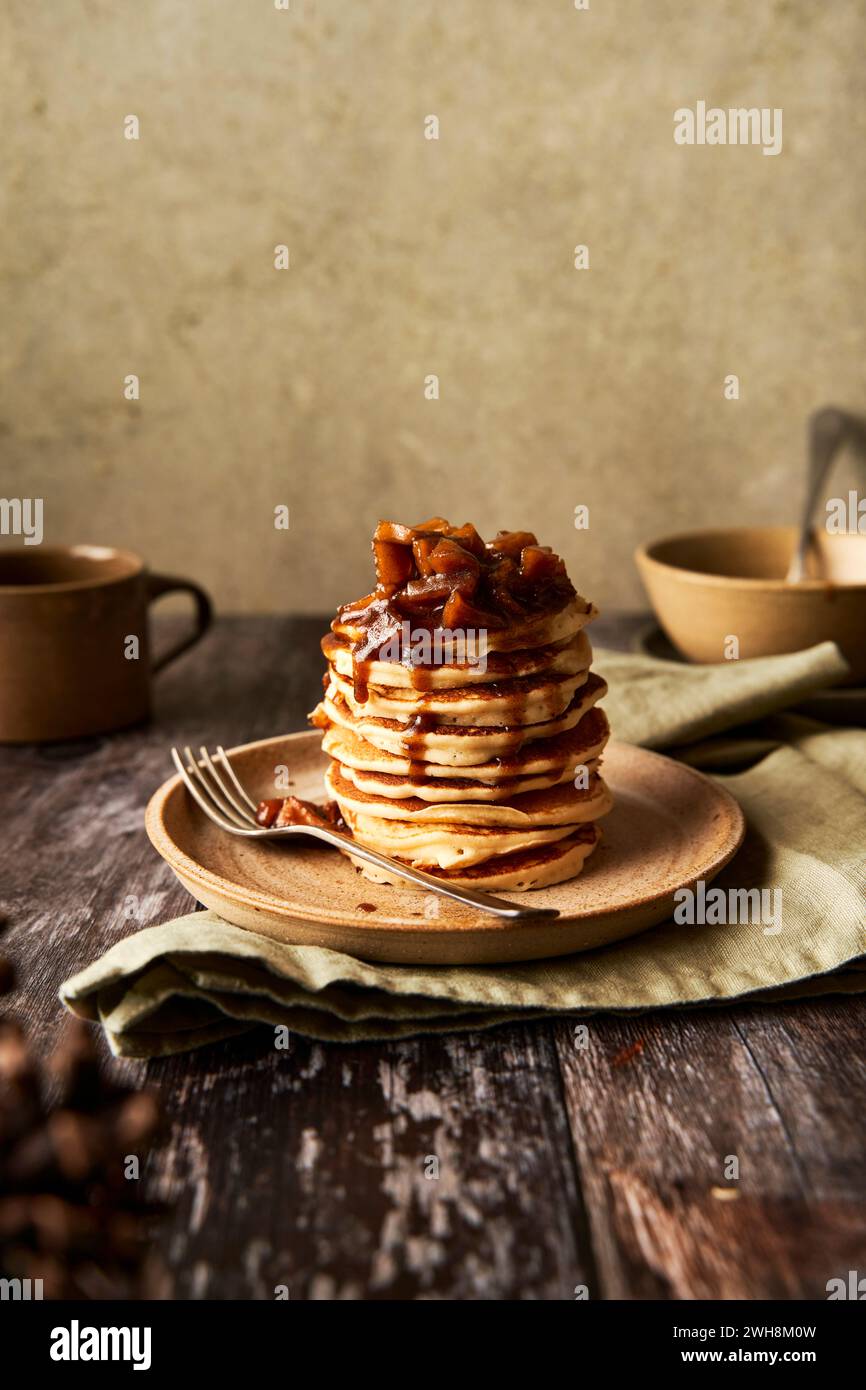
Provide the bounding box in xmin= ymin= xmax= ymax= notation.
xmin=325 ymin=762 xmax=613 ymax=827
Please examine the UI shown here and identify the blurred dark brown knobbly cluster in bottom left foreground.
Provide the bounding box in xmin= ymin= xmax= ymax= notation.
xmin=0 ymin=917 xmax=161 ymax=1298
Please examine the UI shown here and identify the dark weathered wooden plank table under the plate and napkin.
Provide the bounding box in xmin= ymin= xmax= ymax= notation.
xmin=0 ymin=619 xmax=866 ymax=1300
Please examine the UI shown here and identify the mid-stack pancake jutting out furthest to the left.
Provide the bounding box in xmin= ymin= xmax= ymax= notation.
xmin=314 ymin=677 xmax=607 ymax=767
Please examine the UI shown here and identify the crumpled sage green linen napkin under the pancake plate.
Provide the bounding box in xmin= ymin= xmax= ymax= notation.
xmin=61 ymin=642 xmax=866 ymax=1058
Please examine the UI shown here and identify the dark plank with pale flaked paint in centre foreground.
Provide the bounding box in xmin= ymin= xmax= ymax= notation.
xmin=149 ymin=1026 xmax=592 ymax=1298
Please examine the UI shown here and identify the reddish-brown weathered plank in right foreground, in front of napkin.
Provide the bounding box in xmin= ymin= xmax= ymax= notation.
xmin=556 ymin=999 xmax=866 ymax=1298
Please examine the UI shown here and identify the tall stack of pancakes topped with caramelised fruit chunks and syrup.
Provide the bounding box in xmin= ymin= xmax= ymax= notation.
xmin=310 ymin=518 xmax=612 ymax=890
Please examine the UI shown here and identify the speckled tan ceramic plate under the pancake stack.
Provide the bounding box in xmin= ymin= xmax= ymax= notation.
xmin=146 ymin=731 xmax=745 ymax=965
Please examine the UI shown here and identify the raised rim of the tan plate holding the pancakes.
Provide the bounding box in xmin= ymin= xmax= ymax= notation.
xmin=145 ymin=728 xmax=746 ymax=937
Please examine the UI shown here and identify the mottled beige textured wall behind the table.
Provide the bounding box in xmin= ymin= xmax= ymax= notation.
xmin=0 ymin=0 xmax=866 ymax=610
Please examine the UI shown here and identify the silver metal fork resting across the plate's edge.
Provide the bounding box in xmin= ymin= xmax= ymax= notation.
xmin=171 ymin=745 xmax=559 ymax=922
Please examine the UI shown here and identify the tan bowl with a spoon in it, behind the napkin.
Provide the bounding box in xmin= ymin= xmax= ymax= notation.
xmin=635 ymin=527 xmax=866 ymax=685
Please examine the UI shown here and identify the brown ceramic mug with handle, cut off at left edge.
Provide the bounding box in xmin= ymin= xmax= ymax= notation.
xmin=0 ymin=545 xmax=211 ymax=744
